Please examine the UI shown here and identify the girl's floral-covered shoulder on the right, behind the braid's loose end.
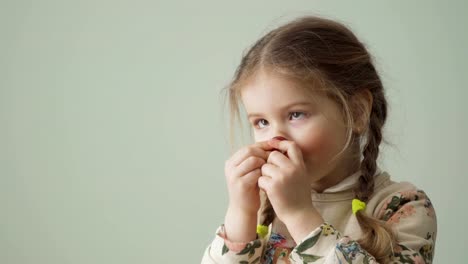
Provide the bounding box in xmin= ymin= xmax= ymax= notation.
xmin=366 ymin=170 xmax=437 ymax=263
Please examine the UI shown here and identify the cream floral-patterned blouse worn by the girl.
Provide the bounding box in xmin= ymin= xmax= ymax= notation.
xmin=202 ymin=172 xmax=437 ymax=264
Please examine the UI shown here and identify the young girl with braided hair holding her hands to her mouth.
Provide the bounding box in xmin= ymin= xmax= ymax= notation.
xmin=202 ymin=16 xmax=437 ymax=263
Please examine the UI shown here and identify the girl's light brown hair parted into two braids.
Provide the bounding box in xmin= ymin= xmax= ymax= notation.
xmin=221 ymin=16 xmax=395 ymax=262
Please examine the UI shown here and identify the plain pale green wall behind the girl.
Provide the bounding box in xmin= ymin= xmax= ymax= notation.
xmin=0 ymin=0 xmax=468 ymax=264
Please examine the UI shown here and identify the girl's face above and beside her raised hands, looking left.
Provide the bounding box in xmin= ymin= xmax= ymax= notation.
xmin=241 ymin=74 xmax=354 ymax=192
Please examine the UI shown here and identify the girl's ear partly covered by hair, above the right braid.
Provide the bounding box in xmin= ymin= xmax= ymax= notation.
xmin=351 ymin=89 xmax=373 ymax=135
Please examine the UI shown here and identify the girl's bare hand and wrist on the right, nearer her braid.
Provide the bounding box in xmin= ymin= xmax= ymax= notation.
xmin=258 ymin=139 xmax=323 ymax=241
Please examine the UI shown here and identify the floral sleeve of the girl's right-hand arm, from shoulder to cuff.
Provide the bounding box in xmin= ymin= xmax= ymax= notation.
xmin=289 ymin=190 xmax=437 ymax=264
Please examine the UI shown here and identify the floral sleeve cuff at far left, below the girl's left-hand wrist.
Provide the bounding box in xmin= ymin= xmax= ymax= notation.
xmin=201 ymin=225 xmax=266 ymax=264
